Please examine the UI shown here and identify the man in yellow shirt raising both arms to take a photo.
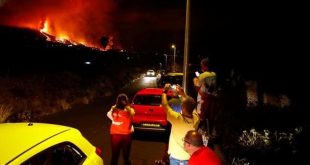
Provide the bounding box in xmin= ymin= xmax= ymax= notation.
xmin=162 ymin=84 xmax=199 ymax=165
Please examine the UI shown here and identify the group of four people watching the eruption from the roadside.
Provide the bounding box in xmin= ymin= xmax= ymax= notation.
xmin=107 ymin=58 xmax=242 ymax=165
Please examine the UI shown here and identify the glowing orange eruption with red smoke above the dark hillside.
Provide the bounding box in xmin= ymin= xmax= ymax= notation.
xmin=0 ymin=0 xmax=117 ymax=50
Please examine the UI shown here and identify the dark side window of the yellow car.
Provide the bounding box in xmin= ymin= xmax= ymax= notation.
xmin=22 ymin=142 xmax=86 ymax=165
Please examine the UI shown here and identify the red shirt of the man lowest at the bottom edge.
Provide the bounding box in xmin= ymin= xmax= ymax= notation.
xmin=188 ymin=147 xmax=222 ymax=165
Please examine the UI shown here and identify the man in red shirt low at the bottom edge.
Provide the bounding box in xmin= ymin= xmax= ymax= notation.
xmin=184 ymin=130 xmax=222 ymax=165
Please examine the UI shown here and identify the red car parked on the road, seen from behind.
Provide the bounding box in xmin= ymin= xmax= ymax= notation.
xmin=131 ymin=88 xmax=181 ymax=132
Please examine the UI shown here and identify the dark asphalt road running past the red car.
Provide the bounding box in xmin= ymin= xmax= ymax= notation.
xmin=37 ymin=78 xmax=165 ymax=165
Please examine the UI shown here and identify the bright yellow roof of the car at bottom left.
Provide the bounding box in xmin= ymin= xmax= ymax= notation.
xmin=0 ymin=123 xmax=77 ymax=164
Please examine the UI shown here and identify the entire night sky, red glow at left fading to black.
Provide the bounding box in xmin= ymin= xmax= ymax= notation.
xmin=0 ymin=0 xmax=308 ymax=89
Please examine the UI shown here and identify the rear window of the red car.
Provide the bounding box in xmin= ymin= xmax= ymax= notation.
xmin=133 ymin=95 xmax=161 ymax=106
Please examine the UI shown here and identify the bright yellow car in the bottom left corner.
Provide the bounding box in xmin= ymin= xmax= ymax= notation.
xmin=0 ymin=123 xmax=103 ymax=165
